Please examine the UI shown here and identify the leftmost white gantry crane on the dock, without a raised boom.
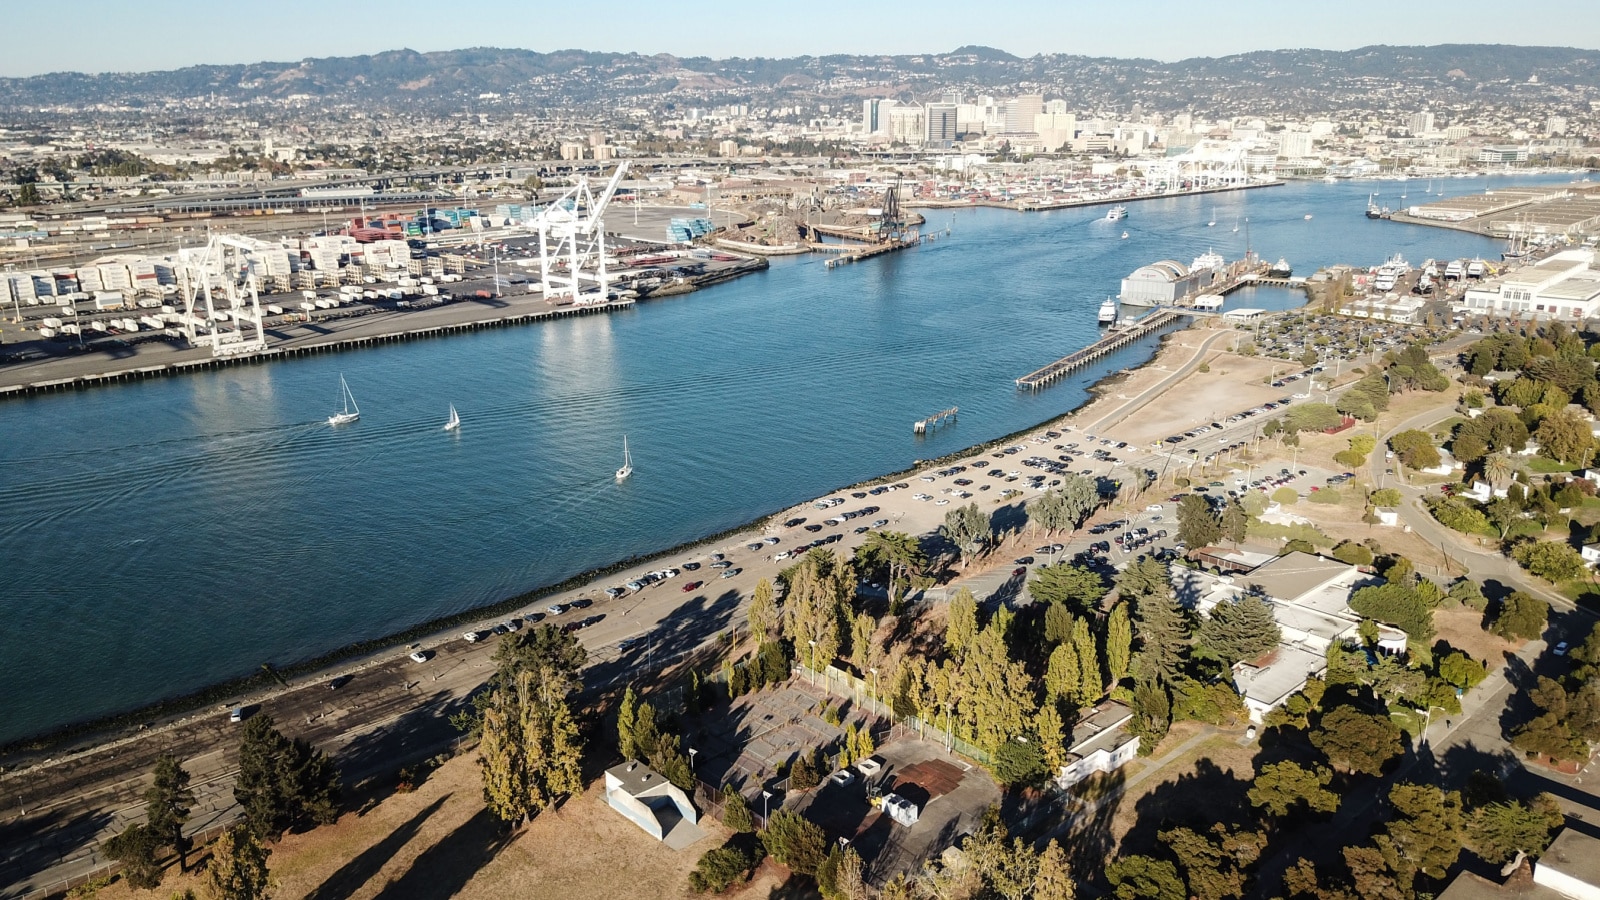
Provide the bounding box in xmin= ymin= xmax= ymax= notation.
xmin=176 ymin=234 xmax=269 ymax=356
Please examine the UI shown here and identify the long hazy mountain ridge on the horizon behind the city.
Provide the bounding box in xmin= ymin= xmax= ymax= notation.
xmin=0 ymin=45 xmax=1600 ymax=110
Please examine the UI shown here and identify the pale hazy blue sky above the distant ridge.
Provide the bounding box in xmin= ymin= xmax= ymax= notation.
xmin=0 ymin=0 xmax=1600 ymax=77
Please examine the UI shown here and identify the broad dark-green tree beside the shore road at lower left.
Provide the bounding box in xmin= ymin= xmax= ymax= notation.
xmin=234 ymin=713 xmax=339 ymax=841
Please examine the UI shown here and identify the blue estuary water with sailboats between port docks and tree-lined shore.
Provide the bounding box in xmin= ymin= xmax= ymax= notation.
xmin=0 ymin=171 xmax=1560 ymax=741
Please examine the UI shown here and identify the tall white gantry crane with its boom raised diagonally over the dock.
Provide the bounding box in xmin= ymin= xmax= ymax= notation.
xmin=534 ymin=160 xmax=627 ymax=304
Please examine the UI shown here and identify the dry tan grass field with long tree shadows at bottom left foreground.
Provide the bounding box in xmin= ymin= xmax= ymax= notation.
xmin=89 ymin=754 xmax=786 ymax=900
